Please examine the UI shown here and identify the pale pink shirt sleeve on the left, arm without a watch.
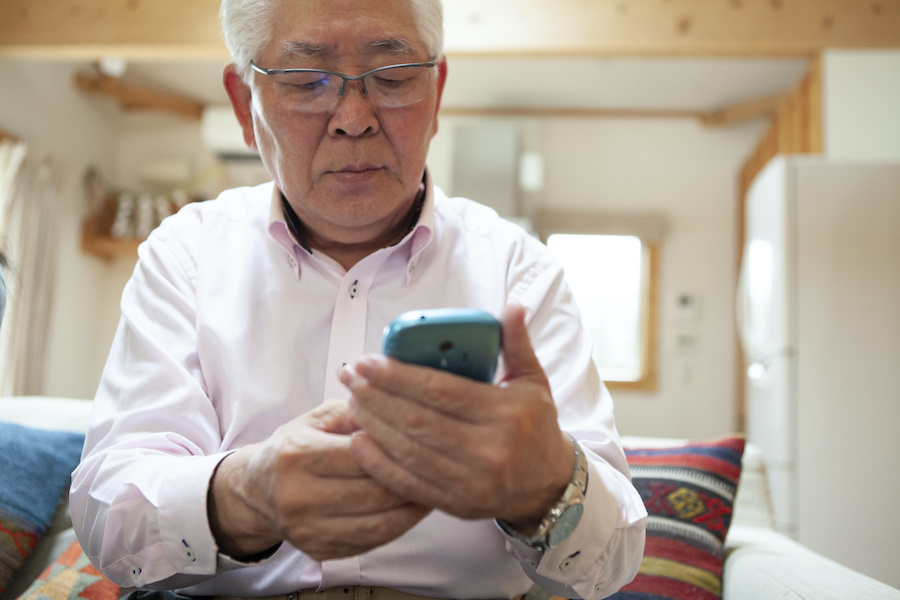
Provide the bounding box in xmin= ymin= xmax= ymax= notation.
xmin=70 ymin=213 xmax=244 ymax=587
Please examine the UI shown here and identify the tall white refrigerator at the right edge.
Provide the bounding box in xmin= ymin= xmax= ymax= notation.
xmin=738 ymin=156 xmax=900 ymax=587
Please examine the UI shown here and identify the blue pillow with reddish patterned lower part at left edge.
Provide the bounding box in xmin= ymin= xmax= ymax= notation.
xmin=0 ymin=423 xmax=84 ymax=593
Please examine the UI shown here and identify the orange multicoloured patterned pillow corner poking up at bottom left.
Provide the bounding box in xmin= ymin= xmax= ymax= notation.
xmin=18 ymin=542 xmax=120 ymax=600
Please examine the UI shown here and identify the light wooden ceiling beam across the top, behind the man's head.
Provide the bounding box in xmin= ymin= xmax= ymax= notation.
xmin=0 ymin=0 xmax=900 ymax=60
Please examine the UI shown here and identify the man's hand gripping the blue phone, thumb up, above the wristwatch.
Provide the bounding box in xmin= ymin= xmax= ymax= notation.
xmin=341 ymin=306 xmax=574 ymax=533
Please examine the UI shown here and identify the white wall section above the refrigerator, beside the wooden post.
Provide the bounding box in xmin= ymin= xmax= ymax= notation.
xmin=822 ymin=50 xmax=900 ymax=161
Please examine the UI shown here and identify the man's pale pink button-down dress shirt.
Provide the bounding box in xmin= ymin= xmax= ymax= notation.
xmin=71 ymin=176 xmax=646 ymax=599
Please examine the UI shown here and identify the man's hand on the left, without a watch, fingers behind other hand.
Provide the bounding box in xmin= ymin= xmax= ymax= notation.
xmin=208 ymin=402 xmax=430 ymax=560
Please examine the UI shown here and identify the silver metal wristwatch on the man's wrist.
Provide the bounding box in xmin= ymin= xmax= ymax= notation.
xmin=497 ymin=438 xmax=588 ymax=550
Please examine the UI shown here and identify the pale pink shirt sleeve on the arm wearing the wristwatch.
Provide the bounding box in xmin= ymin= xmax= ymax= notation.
xmin=507 ymin=241 xmax=647 ymax=599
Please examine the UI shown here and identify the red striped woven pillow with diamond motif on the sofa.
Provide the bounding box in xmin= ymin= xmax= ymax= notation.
xmin=610 ymin=437 xmax=744 ymax=600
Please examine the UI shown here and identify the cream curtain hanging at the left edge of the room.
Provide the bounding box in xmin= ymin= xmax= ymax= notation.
xmin=0 ymin=139 xmax=60 ymax=396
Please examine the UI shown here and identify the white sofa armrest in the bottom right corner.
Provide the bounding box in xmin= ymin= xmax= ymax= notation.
xmin=722 ymin=524 xmax=900 ymax=600
